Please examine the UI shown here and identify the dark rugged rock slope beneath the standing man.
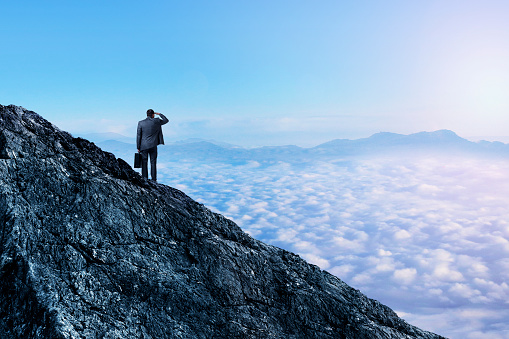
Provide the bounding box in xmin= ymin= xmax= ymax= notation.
xmin=0 ymin=106 xmax=441 ymax=339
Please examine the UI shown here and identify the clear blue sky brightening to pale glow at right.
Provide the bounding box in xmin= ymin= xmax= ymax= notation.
xmin=0 ymin=0 xmax=509 ymax=146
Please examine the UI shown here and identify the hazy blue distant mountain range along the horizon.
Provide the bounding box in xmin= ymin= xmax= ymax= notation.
xmin=89 ymin=130 xmax=509 ymax=163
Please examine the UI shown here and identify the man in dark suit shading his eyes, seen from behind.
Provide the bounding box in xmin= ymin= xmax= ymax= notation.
xmin=136 ymin=109 xmax=168 ymax=181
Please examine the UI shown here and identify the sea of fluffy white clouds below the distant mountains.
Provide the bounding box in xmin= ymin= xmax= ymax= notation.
xmin=159 ymin=154 xmax=509 ymax=338
